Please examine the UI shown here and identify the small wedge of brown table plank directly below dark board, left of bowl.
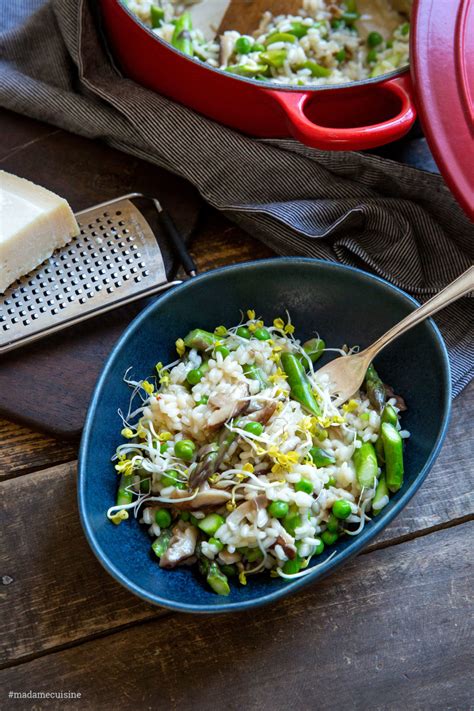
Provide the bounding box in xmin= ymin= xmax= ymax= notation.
xmin=0 ymin=419 xmax=78 ymax=480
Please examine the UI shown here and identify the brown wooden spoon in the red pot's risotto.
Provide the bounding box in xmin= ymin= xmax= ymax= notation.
xmin=219 ymin=0 xmax=303 ymax=35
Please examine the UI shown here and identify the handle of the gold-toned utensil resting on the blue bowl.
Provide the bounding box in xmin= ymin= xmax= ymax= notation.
xmin=364 ymin=267 xmax=474 ymax=360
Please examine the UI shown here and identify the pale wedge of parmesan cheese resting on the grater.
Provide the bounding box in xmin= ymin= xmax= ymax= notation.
xmin=0 ymin=170 xmax=79 ymax=294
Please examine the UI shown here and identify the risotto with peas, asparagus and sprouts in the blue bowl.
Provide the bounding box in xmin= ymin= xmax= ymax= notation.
xmin=107 ymin=310 xmax=409 ymax=595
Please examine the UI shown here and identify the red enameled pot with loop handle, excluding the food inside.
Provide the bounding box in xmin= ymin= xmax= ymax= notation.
xmin=101 ymin=0 xmax=416 ymax=150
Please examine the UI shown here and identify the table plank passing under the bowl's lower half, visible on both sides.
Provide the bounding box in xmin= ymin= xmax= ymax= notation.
xmin=0 ymin=388 xmax=474 ymax=660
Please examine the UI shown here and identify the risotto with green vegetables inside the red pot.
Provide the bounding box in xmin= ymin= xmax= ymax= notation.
xmin=126 ymin=0 xmax=410 ymax=85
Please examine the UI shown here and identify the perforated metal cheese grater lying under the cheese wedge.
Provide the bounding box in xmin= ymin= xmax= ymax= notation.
xmin=0 ymin=193 xmax=184 ymax=354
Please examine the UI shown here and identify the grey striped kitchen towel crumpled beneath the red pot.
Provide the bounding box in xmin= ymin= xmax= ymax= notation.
xmin=0 ymin=0 xmax=474 ymax=394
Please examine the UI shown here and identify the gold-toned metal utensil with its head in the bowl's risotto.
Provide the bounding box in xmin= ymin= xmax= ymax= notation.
xmin=316 ymin=267 xmax=474 ymax=406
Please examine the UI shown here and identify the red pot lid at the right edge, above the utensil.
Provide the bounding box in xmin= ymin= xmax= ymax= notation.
xmin=411 ymin=0 xmax=474 ymax=219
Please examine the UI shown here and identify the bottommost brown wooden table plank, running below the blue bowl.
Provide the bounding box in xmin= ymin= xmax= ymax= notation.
xmin=0 ymin=524 xmax=473 ymax=711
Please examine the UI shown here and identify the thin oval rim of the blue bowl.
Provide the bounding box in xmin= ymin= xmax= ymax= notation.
xmin=77 ymin=257 xmax=452 ymax=614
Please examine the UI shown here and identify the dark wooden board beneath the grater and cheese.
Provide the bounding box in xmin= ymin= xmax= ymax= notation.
xmin=0 ymin=111 xmax=203 ymax=438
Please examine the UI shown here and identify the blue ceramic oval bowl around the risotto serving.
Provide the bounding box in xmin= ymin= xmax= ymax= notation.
xmin=79 ymin=258 xmax=451 ymax=613
